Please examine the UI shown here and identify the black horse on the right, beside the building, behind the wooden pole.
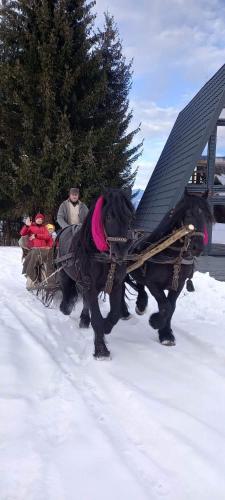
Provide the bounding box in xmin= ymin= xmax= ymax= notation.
xmin=122 ymin=191 xmax=213 ymax=345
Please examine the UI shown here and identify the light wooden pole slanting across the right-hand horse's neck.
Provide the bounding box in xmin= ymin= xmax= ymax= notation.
xmin=127 ymin=224 xmax=194 ymax=273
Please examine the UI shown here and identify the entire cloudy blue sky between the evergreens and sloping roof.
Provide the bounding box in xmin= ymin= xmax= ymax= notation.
xmin=96 ymin=0 xmax=225 ymax=188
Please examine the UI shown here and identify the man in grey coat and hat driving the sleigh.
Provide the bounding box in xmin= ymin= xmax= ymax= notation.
xmin=57 ymin=188 xmax=88 ymax=229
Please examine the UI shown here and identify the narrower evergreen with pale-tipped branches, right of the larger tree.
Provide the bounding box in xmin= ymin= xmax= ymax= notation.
xmin=89 ymin=14 xmax=142 ymax=200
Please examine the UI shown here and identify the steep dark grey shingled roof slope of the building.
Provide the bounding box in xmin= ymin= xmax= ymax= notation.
xmin=135 ymin=64 xmax=225 ymax=232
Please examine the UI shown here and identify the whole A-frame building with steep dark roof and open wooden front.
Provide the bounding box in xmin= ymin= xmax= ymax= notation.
xmin=135 ymin=65 xmax=225 ymax=256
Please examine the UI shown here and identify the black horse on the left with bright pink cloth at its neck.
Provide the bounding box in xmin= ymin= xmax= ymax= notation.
xmin=58 ymin=189 xmax=134 ymax=358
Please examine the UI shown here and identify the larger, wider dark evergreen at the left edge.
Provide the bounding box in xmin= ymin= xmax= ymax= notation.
xmin=0 ymin=0 xmax=102 ymax=219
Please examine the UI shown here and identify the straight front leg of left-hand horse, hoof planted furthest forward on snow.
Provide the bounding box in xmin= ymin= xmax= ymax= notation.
xmin=88 ymin=295 xmax=110 ymax=359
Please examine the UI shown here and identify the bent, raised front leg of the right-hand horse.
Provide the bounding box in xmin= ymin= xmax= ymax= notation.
xmin=148 ymin=282 xmax=172 ymax=330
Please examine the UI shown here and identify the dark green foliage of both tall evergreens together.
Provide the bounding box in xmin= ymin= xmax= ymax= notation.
xmin=0 ymin=0 xmax=140 ymax=216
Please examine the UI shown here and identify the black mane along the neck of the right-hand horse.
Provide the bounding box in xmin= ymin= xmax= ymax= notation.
xmin=141 ymin=191 xmax=214 ymax=250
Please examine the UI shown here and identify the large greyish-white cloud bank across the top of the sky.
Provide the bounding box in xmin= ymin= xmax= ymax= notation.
xmin=97 ymin=0 xmax=225 ymax=83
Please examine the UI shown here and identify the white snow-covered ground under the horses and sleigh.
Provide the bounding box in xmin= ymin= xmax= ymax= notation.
xmin=0 ymin=248 xmax=225 ymax=500
